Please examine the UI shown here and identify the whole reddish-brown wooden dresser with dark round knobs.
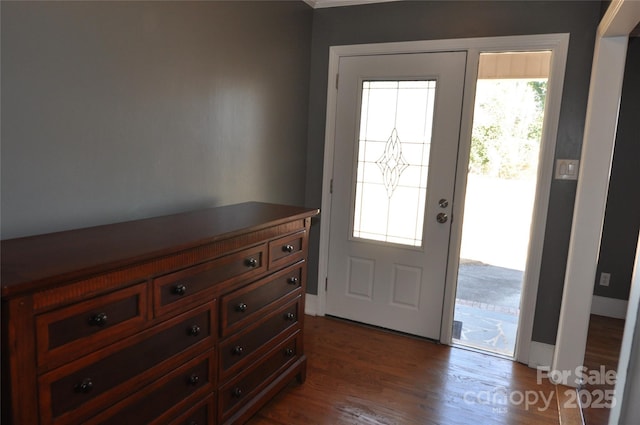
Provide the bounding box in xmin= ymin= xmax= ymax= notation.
xmin=1 ymin=203 xmax=318 ymax=425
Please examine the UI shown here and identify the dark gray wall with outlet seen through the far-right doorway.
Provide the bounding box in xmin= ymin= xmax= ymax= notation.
xmin=594 ymin=37 xmax=640 ymax=300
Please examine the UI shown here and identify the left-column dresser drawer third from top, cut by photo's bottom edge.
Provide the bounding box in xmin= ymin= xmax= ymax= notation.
xmin=94 ymin=351 xmax=215 ymax=425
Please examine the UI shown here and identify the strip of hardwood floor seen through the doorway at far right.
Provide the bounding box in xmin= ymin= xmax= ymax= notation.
xmin=582 ymin=315 xmax=624 ymax=425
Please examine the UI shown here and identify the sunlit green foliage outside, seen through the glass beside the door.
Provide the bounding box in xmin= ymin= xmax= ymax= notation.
xmin=469 ymin=80 xmax=547 ymax=179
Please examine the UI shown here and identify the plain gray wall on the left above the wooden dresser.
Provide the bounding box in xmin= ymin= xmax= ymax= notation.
xmin=1 ymin=1 xmax=313 ymax=239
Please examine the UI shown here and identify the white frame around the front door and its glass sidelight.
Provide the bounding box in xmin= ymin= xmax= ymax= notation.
xmin=311 ymin=34 xmax=569 ymax=363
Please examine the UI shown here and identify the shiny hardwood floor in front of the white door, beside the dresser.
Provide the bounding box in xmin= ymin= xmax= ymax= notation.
xmin=248 ymin=316 xmax=559 ymax=425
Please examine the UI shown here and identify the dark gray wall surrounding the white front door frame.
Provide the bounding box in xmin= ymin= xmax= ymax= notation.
xmin=306 ymin=1 xmax=601 ymax=344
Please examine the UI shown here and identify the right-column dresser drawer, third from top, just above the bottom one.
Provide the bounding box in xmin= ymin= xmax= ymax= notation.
xmin=219 ymin=297 xmax=302 ymax=382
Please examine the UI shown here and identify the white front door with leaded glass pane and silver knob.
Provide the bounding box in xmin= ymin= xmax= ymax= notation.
xmin=326 ymin=52 xmax=466 ymax=340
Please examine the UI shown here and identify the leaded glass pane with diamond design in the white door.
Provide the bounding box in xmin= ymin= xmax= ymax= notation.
xmin=353 ymin=80 xmax=436 ymax=246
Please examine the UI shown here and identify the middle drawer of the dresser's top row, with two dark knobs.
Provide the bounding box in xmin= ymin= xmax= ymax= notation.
xmin=153 ymin=244 xmax=266 ymax=316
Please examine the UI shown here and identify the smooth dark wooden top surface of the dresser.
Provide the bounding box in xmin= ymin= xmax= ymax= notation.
xmin=0 ymin=202 xmax=318 ymax=298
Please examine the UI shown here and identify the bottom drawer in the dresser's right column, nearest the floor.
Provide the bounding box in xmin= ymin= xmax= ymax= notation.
xmin=218 ymin=332 xmax=302 ymax=423
